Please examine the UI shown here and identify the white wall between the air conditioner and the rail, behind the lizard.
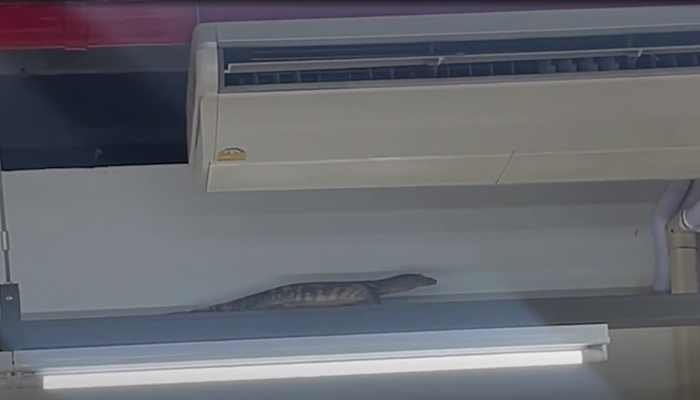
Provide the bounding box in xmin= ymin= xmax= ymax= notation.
xmin=4 ymin=165 xmax=661 ymax=315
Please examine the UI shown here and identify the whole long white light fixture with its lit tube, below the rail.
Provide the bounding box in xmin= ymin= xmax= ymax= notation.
xmin=15 ymin=325 xmax=610 ymax=389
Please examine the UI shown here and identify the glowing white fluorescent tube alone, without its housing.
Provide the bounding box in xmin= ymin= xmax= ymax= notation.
xmin=44 ymin=350 xmax=584 ymax=389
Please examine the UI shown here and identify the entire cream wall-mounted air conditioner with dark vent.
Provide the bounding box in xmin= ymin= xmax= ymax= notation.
xmin=188 ymin=6 xmax=700 ymax=192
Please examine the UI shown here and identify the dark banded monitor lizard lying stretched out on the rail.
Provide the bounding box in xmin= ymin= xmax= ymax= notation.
xmin=188 ymin=274 xmax=437 ymax=313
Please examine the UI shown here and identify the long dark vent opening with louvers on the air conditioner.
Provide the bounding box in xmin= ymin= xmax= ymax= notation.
xmin=223 ymin=31 xmax=700 ymax=91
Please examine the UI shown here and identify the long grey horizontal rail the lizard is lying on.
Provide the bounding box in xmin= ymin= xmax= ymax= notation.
xmin=0 ymin=294 xmax=700 ymax=351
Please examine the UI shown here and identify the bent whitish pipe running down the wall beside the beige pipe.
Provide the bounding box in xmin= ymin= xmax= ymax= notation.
xmin=651 ymin=181 xmax=697 ymax=293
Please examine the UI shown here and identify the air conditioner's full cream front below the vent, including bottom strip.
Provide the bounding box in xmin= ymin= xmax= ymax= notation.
xmin=208 ymin=75 xmax=700 ymax=191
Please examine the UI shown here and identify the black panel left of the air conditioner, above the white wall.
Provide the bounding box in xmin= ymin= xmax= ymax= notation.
xmin=0 ymin=73 xmax=187 ymax=171
